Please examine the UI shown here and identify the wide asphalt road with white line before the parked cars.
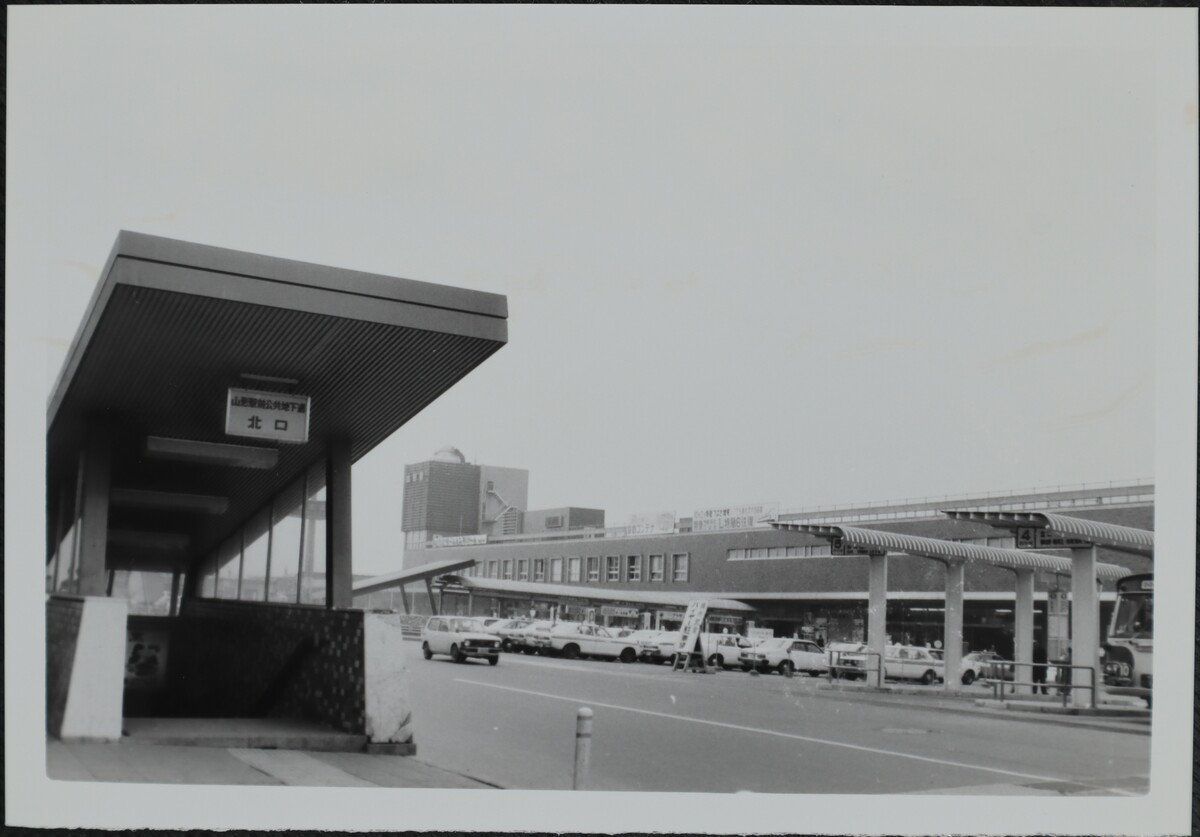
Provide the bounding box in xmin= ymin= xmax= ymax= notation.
xmin=406 ymin=643 xmax=1150 ymax=795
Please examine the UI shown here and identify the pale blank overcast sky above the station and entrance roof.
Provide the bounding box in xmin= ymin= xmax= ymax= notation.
xmin=8 ymin=7 xmax=1190 ymax=580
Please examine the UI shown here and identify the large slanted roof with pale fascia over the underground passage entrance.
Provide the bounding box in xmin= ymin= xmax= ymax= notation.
xmin=47 ymin=231 xmax=508 ymax=570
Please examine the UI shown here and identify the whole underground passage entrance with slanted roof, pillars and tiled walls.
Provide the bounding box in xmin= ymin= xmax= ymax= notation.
xmin=46 ymin=231 xmax=508 ymax=752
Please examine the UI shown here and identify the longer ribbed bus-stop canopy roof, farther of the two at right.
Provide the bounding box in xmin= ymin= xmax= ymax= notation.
xmin=770 ymin=520 xmax=1129 ymax=579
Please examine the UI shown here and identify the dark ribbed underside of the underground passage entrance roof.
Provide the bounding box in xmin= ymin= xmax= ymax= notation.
xmin=49 ymin=285 xmax=503 ymax=556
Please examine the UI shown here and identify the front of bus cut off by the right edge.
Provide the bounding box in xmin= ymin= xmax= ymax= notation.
xmin=1104 ymin=573 xmax=1154 ymax=706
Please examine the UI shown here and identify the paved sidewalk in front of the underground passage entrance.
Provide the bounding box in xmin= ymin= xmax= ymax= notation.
xmin=46 ymin=739 xmax=496 ymax=788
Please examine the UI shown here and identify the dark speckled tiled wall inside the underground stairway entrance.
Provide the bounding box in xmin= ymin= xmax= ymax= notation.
xmin=164 ymin=600 xmax=366 ymax=735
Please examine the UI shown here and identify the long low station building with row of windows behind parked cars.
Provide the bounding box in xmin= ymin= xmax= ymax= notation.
xmin=372 ymin=483 xmax=1154 ymax=658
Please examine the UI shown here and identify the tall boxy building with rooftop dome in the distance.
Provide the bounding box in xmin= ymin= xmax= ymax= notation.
xmin=401 ymin=447 xmax=529 ymax=552
